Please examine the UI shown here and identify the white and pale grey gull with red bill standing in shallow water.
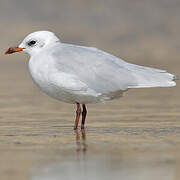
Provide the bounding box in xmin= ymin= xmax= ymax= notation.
xmin=5 ymin=31 xmax=178 ymax=130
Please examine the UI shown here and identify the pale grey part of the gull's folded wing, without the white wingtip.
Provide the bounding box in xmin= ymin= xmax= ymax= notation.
xmin=52 ymin=44 xmax=136 ymax=94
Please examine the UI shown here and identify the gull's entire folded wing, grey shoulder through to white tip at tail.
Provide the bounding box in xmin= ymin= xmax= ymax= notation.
xmin=52 ymin=44 xmax=176 ymax=94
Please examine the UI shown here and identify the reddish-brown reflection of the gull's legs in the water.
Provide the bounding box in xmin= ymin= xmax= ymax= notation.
xmin=74 ymin=129 xmax=87 ymax=153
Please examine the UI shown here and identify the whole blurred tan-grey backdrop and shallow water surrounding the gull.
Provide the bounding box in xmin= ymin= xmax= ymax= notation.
xmin=0 ymin=0 xmax=180 ymax=180
